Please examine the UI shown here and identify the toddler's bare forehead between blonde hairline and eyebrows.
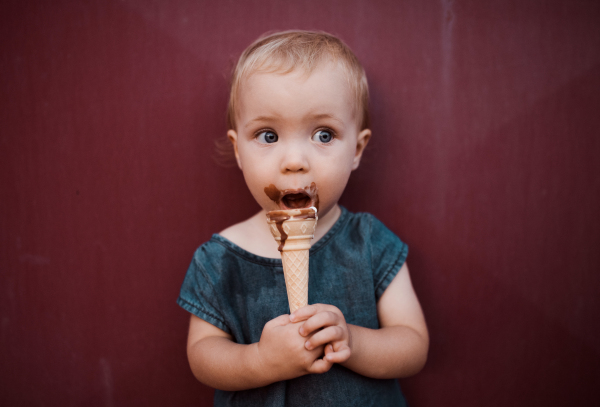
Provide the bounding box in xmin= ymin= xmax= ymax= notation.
xmin=236 ymin=63 xmax=357 ymax=124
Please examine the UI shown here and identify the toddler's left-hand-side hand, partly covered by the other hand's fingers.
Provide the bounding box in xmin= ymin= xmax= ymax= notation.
xmin=257 ymin=314 xmax=332 ymax=381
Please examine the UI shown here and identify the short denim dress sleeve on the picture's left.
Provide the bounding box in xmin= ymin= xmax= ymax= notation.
xmin=177 ymin=245 xmax=231 ymax=334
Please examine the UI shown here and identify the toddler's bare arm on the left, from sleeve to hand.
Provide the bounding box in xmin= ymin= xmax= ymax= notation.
xmin=187 ymin=315 xmax=332 ymax=391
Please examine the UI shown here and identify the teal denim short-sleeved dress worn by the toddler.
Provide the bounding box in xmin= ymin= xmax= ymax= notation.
xmin=177 ymin=208 xmax=408 ymax=407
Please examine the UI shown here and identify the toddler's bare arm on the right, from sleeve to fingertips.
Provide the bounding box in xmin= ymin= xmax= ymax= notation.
xmin=292 ymin=264 xmax=429 ymax=379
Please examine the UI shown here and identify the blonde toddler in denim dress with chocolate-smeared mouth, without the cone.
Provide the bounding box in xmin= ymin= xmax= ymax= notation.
xmin=178 ymin=31 xmax=429 ymax=406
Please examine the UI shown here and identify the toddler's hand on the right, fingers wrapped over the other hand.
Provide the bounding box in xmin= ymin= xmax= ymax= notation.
xmin=290 ymin=304 xmax=352 ymax=363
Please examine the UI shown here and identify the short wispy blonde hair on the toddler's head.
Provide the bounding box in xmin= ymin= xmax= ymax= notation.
xmin=227 ymin=31 xmax=370 ymax=130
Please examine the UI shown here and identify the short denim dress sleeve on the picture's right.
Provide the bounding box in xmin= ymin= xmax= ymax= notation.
xmin=370 ymin=216 xmax=408 ymax=301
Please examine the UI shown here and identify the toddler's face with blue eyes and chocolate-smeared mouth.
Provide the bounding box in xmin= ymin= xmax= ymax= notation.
xmin=228 ymin=64 xmax=371 ymax=217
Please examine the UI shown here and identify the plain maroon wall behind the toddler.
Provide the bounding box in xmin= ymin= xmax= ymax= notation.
xmin=0 ymin=0 xmax=600 ymax=407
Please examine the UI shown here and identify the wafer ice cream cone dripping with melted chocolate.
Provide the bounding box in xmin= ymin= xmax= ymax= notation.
xmin=267 ymin=207 xmax=318 ymax=313
